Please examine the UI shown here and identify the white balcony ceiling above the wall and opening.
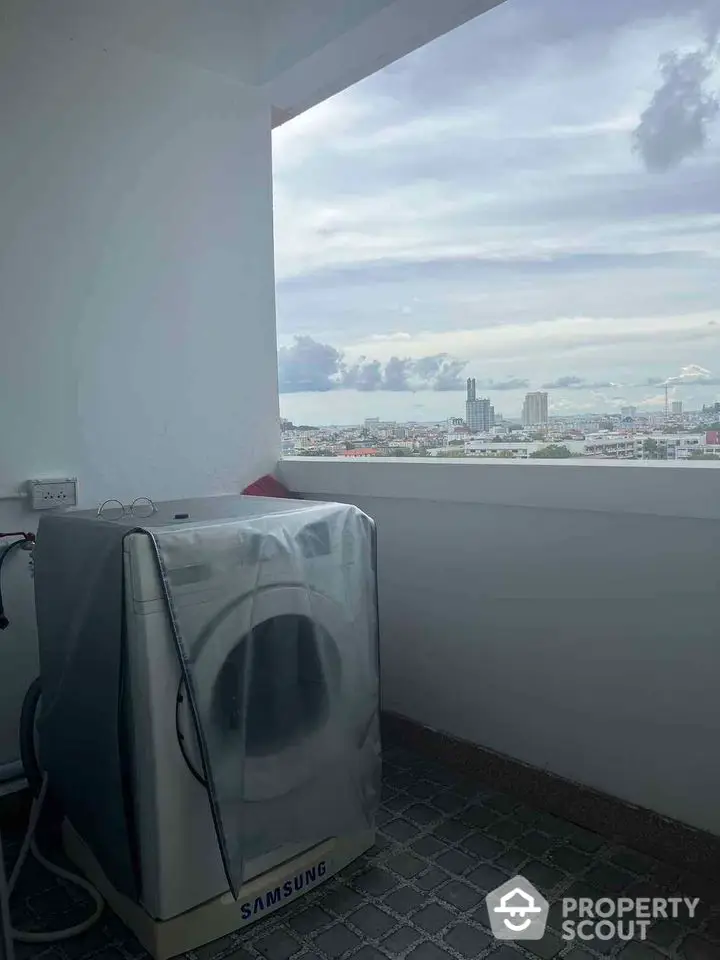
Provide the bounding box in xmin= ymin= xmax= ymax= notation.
xmin=3 ymin=0 xmax=502 ymax=125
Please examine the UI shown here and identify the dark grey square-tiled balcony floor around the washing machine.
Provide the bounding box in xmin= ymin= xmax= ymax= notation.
xmin=8 ymin=748 xmax=720 ymax=960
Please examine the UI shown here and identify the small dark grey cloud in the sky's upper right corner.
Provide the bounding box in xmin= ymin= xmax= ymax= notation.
xmin=633 ymin=41 xmax=720 ymax=173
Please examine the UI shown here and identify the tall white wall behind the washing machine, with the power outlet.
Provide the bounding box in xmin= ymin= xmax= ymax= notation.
xmin=0 ymin=25 xmax=279 ymax=767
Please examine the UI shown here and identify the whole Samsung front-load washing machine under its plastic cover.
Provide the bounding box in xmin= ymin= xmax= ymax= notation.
xmin=35 ymin=497 xmax=380 ymax=957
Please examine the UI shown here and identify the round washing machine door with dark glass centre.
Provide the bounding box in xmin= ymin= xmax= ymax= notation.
xmin=178 ymin=587 xmax=348 ymax=802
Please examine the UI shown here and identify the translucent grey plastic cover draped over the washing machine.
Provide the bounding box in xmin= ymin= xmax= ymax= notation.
xmin=35 ymin=497 xmax=380 ymax=898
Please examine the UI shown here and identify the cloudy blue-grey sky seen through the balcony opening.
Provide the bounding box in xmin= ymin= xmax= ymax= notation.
xmin=273 ymin=0 xmax=720 ymax=424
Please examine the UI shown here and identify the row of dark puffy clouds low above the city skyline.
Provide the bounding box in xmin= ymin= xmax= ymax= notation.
xmin=278 ymin=336 xmax=466 ymax=393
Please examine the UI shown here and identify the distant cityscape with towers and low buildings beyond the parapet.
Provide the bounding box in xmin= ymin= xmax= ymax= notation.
xmin=281 ymin=378 xmax=720 ymax=462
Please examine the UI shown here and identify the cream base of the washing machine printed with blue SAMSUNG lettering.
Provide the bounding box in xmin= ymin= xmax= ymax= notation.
xmin=63 ymin=820 xmax=375 ymax=960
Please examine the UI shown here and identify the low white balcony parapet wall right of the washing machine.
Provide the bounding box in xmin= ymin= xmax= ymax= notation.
xmin=281 ymin=459 xmax=720 ymax=833
